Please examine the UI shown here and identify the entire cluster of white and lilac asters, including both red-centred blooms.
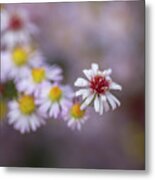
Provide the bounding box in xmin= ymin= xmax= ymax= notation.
xmin=0 ymin=5 xmax=122 ymax=133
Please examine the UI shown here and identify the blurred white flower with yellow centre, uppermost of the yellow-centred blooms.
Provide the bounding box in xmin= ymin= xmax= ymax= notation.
xmin=1 ymin=46 xmax=43 ymax=80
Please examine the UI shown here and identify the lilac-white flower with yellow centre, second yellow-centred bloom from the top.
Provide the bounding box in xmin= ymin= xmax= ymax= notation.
xmin=17 ymin=65 xmax=62 ymax=97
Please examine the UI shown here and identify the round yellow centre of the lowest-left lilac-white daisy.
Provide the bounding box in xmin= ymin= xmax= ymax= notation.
xmin=19 ymin=95 xmax=36 ymax=115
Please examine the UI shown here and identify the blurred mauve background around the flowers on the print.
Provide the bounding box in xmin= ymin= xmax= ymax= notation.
xmin=0 ymin=1 xmax=145 ymax=169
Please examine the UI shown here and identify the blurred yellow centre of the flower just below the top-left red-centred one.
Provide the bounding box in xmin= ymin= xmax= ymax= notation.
xmin=12 ymin=47 xmax=28 ymax=67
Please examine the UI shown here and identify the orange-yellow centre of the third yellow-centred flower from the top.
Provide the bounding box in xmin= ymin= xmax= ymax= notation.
xmin=49 ymin=86 xmax=62 ymax=101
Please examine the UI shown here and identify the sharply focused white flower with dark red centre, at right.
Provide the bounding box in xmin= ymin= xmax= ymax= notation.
xmin=75 ymin=63 xmax=122 ymax=115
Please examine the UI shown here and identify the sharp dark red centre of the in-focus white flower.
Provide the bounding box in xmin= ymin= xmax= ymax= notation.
xmin=90 ymin=76 xmax=109 ymax=94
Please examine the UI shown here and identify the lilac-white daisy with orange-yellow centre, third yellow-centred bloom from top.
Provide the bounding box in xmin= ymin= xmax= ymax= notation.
xmin=36 ymin=83 xmax=73 ymax=119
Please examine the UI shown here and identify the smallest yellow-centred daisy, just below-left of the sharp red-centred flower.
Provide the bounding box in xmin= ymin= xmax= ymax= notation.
xmin=65 ymin=102 xmax=88 ymax=130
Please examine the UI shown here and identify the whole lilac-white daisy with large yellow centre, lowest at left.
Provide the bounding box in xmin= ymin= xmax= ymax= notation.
xmin=7 ymin=95 xmax=45 ymax=134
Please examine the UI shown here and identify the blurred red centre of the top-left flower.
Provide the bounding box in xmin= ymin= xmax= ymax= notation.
xmin=10 ymin=15 xmax=23 ymax=31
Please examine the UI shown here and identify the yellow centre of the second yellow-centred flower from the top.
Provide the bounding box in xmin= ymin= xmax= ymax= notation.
xmin=32 ymin=68 xmax=45 ymax=83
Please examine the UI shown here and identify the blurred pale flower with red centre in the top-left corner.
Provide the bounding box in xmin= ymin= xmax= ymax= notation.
xmin=2 ymin=9 xmax=38 ymax=48
